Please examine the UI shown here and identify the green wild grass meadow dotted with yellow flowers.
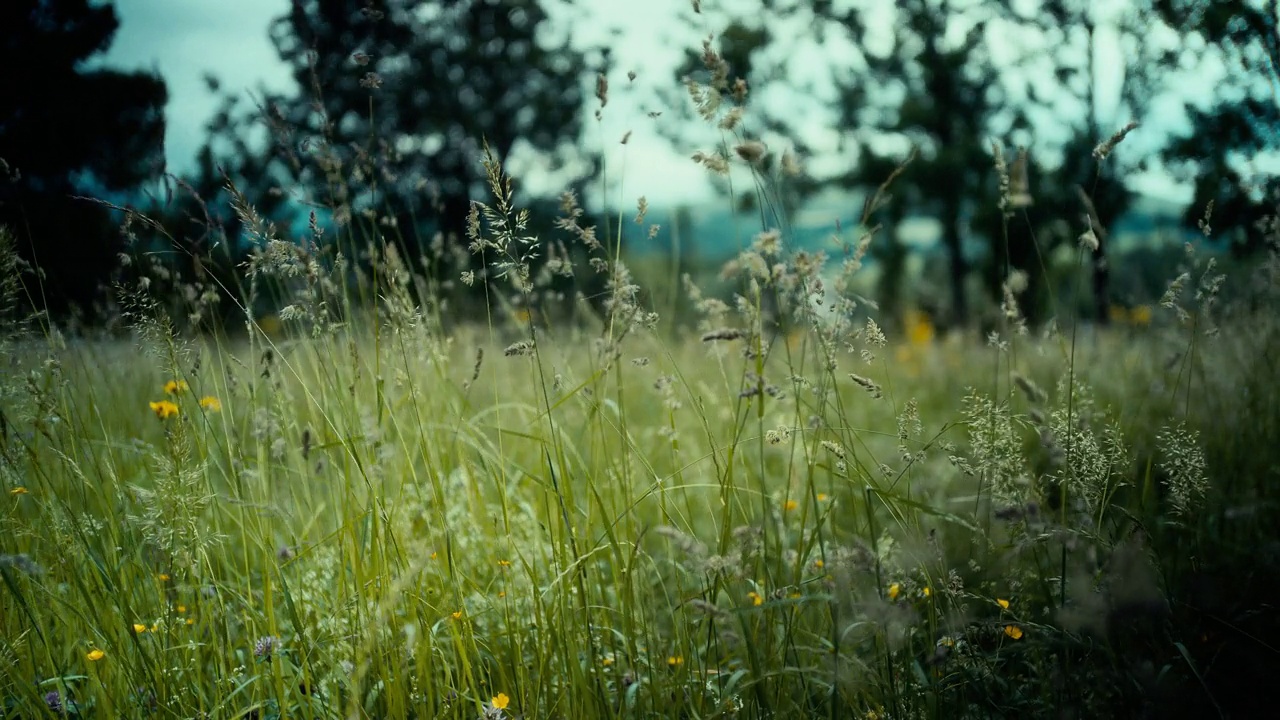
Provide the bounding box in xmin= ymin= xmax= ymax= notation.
xmin=0 ymin=4 xmax=1280 ymax=720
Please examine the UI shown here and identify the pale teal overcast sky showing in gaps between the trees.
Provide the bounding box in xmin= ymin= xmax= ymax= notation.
xmin=97 ymin=0 xmax=1211 ymax=204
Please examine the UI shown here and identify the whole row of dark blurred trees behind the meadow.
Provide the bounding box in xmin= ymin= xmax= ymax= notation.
xmin=0 ymin=0 xmax=1280 ymax=323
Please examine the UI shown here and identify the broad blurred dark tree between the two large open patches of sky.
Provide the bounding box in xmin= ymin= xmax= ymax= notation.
xmin=221 ymin=0 xmax=590 ymax=258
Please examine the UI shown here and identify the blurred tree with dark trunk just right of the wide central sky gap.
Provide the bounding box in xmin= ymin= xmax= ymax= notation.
xmin=678 ymin=0 xmax=1002 ymax=323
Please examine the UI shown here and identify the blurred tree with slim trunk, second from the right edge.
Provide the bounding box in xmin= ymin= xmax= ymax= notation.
xmin=975 ymin=0 xmax=1169 ymax=323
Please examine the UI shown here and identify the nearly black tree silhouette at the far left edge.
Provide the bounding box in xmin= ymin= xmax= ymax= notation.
xmin=0 ymin=0 xmax=168 ymax=315
